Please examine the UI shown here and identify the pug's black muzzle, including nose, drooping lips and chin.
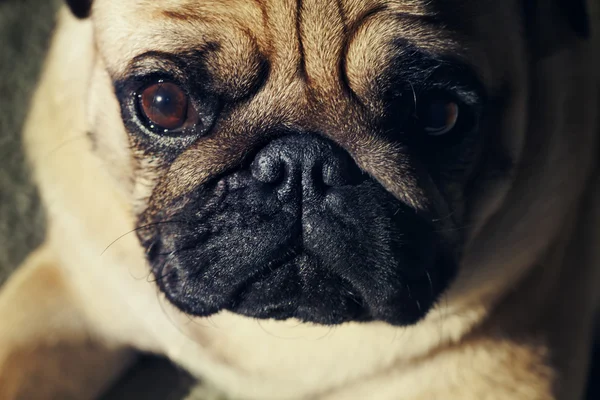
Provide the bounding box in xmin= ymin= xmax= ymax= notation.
xmin=139 ymin=139 xmax=456 ymax=325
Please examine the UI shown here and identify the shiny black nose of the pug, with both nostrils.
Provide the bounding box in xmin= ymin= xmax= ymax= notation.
xmin=250 ymin=135 xmax=365 ymax=197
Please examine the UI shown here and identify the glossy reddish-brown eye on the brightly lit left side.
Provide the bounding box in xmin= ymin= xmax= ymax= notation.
xmin=138 ymin=81 xmax=195 ymax=132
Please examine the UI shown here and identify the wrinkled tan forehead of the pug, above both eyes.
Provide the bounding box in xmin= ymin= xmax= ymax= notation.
xmin=93 ymin=0 xmax=519 ymax=90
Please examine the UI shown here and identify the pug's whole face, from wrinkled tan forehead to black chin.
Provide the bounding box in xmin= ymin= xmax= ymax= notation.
xmin=72 ymin=0 xmax=592 ymax=325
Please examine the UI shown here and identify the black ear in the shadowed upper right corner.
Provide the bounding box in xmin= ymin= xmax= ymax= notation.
xmin=523 ymin=0 xmax=591 ymax=57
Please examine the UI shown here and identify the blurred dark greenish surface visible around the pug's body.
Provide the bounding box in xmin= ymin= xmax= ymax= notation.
xmin=0 ymin=0 xmax=600 ymax=400
